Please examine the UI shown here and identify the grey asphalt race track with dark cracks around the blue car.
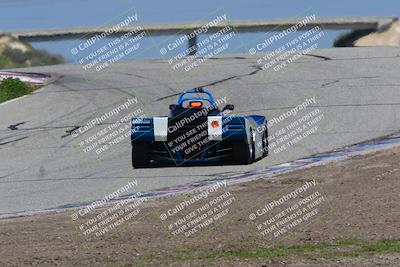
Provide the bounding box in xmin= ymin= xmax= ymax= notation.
xmin=0 ymin=47 xmax=400 ymax=215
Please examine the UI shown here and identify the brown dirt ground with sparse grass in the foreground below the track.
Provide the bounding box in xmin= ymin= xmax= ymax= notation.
xmin=0 ymin=147 xmax=400 ymax=266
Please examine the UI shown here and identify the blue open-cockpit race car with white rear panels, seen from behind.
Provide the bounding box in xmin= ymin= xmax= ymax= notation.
xmin=131 ymin=88 xmax=268 ymax=168
